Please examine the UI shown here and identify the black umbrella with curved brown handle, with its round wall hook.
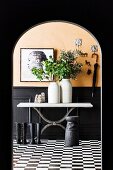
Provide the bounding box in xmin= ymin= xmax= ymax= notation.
xmin=91 ymin=45 xmax=99 ymax=97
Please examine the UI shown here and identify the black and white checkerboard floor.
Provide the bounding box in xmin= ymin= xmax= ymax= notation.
xmin=13 ymin=140 xmax=101 ymax=170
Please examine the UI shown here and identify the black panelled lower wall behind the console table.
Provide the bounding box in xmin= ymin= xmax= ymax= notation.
xmin=12 ymin=87 xmax=101 ymax=140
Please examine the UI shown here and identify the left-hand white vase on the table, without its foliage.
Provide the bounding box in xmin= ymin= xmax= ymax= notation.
xmin=48 ymin=82 xmax=60 ymax=103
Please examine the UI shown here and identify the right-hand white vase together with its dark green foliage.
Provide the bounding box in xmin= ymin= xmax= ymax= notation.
xmin=55 ymin=50 xmax=82 ymax=103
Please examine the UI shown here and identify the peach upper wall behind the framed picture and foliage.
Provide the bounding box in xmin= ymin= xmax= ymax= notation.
xmin=13 ymin=21 xmax=102 ymax=87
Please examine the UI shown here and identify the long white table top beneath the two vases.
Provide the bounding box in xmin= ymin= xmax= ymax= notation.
xmin=17 ymin=102 xmax=93 ymax=108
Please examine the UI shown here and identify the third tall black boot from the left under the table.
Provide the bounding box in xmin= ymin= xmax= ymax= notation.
xmin=29 ymin=123 xmax=35 ymax=144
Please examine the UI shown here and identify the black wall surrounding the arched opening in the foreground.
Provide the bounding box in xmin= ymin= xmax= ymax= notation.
xmin=0 ymin=0 xmax=113 ymax=170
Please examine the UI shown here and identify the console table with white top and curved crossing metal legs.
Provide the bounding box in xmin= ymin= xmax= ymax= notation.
xmin=17 ymin=102 xmax=93 ymax=133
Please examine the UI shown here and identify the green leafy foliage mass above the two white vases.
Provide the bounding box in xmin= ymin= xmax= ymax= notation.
xmin=32 ymin=50 xmax=82 ymax=81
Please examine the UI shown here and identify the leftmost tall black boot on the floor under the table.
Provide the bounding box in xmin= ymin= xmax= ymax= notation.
xmin=16 ymin=122 xmax=22 ymax=144
